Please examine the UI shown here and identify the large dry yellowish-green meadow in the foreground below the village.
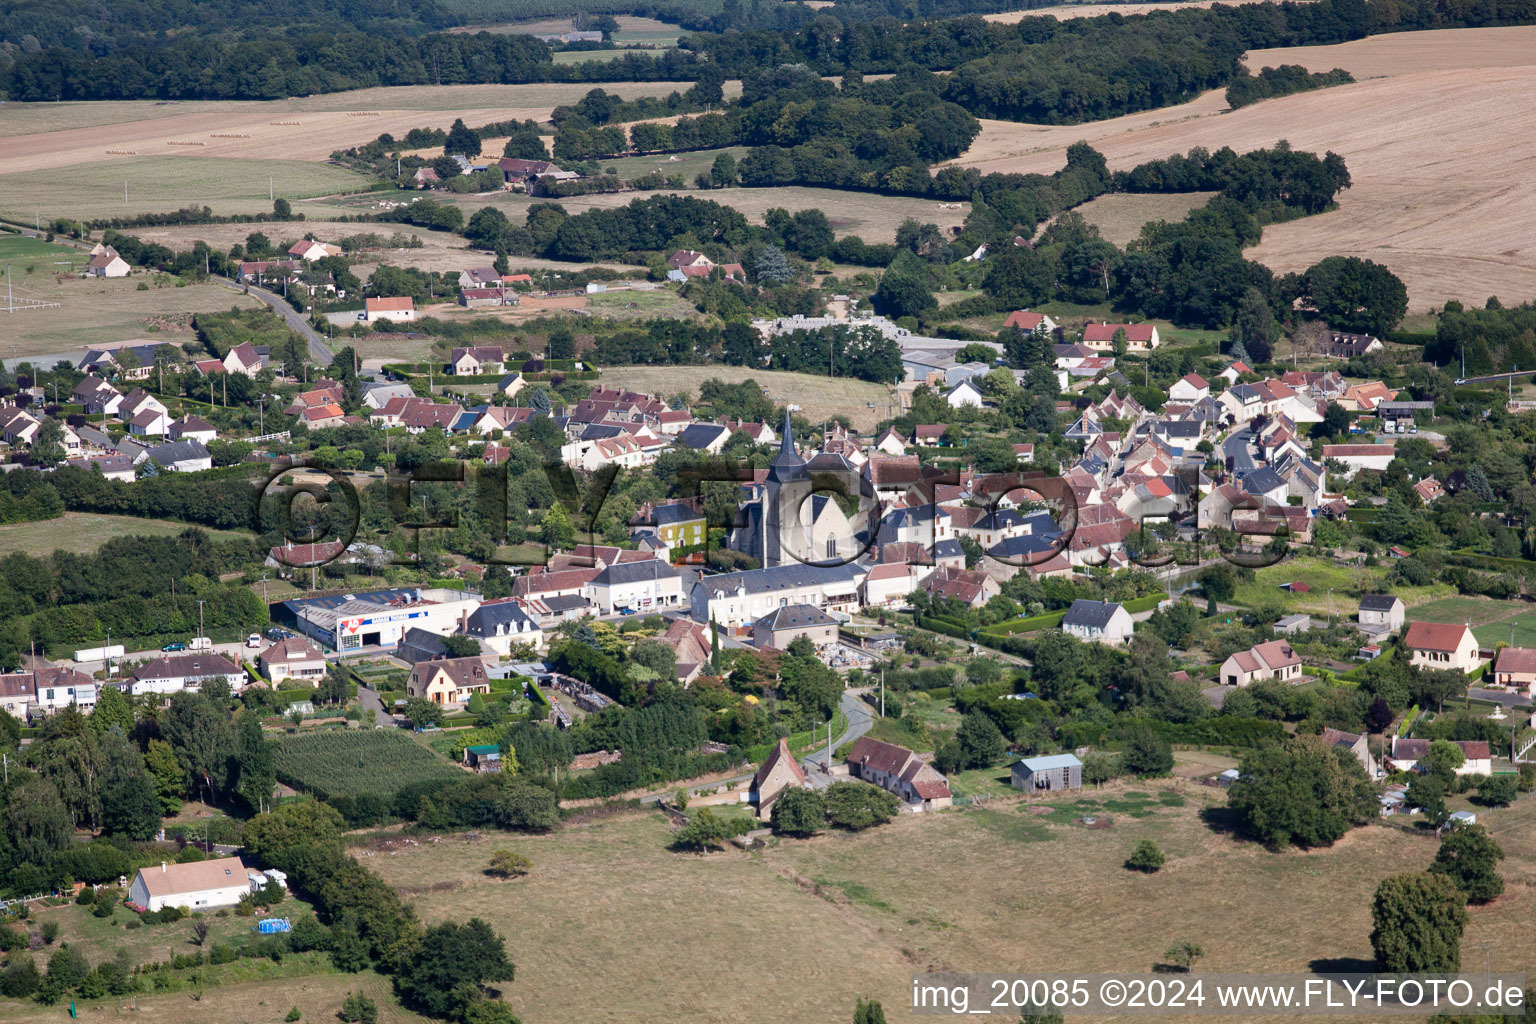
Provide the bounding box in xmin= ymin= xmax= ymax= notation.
xmin=356 ymin=792 xmax=1536 ymax=1024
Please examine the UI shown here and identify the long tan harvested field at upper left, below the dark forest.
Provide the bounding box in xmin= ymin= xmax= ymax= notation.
xmin=0 ymin=81 xmax=712 ymax=173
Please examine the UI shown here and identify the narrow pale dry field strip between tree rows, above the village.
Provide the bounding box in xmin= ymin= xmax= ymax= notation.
xmin=449 ymin=186 xmax=971 ymax=243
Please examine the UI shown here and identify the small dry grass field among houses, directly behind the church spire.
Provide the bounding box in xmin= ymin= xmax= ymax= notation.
xmin=602 ymin=365 xmax=892 ymax=430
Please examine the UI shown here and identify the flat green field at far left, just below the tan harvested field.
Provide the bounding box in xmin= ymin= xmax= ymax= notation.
xmin=0 ymin=155 xmax=369 ymax=221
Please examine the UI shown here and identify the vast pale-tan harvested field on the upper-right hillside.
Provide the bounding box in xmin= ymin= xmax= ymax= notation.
xmin=957 ymin=37 xmax=1536 ymax=312
